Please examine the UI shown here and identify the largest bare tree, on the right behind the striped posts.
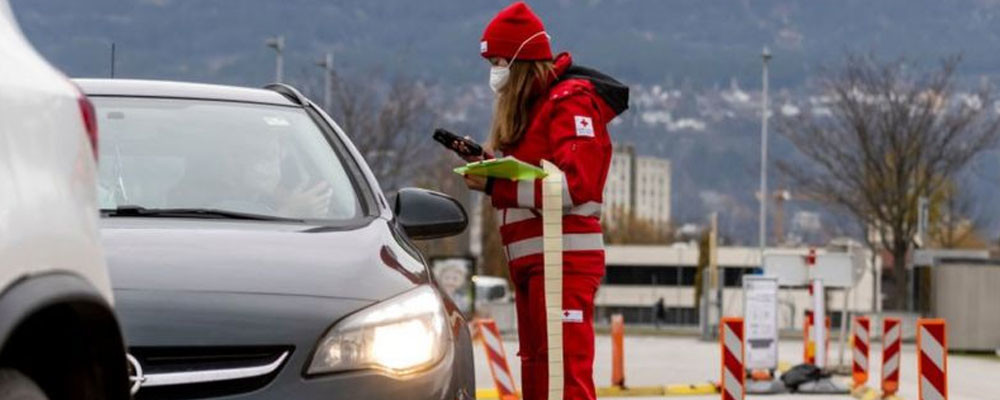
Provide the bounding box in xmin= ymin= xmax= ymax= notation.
xmin=778 ymin=55 xmax=1000 ymax=309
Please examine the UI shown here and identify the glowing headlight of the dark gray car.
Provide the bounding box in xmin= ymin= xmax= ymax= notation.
xmin=307 ymin=286 xmax=450 ymax=375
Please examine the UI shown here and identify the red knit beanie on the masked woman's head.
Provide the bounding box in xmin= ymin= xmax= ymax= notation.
xmin=479 ymin=1 xmax=552 ymax=60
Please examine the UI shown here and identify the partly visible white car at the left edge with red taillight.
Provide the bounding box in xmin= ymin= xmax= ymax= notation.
xmin=0 ymin=0 xmax=129 ymax=399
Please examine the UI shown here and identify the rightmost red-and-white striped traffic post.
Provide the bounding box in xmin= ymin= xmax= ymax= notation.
xmin=917 ymin=318 xmax=948 ymax=400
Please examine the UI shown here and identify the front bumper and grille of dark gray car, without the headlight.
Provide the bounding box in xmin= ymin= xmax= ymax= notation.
xmin=116 ymin=291 xmax=475 ymax=400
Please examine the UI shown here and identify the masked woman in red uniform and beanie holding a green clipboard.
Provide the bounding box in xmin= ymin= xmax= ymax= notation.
xmin=466 ymin=2 xmax=628 ymax=400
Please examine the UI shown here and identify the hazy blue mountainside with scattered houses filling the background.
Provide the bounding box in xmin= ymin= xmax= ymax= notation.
xmin=11 ymin=0 xmax=1000 ymax=243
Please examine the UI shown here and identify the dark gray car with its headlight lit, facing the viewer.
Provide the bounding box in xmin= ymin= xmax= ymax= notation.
xmin=77 ymin=80 xmax=474 ymax=399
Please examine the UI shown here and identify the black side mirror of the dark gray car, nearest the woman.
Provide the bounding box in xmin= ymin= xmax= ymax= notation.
xmin=392 ymin=188 xmax=469 ymax=240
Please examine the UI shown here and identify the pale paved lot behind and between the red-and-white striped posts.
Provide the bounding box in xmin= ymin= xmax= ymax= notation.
xmin=475 ymin=335 xmax=1000 ymax=400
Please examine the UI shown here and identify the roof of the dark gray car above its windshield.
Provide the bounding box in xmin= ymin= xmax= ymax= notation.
xmin=73 ymin=79 xmax=298 ymax=106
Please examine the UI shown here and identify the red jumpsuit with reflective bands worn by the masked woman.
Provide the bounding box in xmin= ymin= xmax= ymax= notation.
xmin=487 ymin=53 xmax=628 ymax=400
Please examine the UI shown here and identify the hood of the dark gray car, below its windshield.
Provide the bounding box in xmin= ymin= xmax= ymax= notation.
xmin=102 ymin=218 xmax=428 ymax=301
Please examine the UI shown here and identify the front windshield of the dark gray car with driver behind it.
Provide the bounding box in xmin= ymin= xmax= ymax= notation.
xmin=92 ymin=97 xmax=361 ymax=220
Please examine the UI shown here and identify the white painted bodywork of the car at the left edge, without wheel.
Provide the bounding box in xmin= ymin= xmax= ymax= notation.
xmin=0 ymin=0 xmax=112 ymax=304
